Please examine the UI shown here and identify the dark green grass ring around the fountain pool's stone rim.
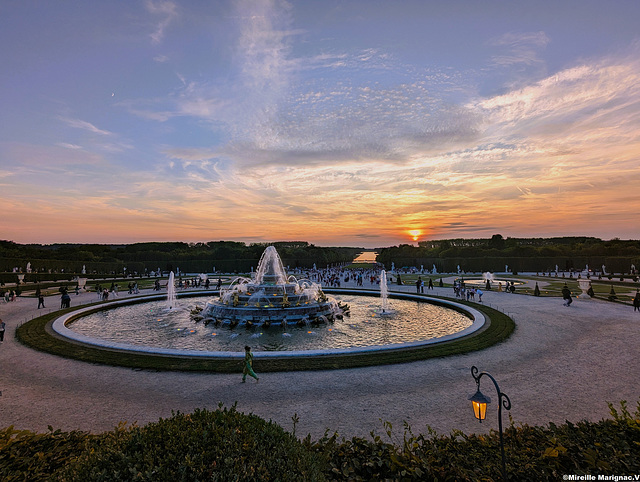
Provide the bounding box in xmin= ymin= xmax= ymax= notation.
xmin=16 ymin=290 xmax=515 ymax=373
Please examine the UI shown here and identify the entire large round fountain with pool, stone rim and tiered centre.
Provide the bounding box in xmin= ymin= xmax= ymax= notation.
xmin=42 ymin=247 xmax=500 ymax=371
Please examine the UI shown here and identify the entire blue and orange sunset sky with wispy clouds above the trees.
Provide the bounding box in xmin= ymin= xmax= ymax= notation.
xmin=0 ymin=0 xmax=640 ymax=247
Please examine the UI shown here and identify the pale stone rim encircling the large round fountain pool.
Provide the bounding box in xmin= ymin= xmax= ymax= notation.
xmin=51 ymin=288 xmax=486 ymax=359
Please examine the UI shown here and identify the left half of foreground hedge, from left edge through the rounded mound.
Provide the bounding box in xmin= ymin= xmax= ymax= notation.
xmin=0 ymin=406 xmax=324 ymax=482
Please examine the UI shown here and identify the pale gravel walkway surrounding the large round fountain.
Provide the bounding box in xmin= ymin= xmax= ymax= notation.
xmin=0 ymin=286 xmax=640 ymax=438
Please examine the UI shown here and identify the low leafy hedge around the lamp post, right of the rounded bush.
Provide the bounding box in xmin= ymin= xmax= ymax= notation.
xmin=304 ymin=402 xmax=640 ymax=481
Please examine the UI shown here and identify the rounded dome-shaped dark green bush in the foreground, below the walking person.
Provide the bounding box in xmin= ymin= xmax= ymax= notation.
xmin=63 ymin=406 xmax=323 ymax=482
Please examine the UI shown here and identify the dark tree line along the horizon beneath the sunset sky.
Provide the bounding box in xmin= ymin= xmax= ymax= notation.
xmin=0 ymin=234 xmax=640 ymax=274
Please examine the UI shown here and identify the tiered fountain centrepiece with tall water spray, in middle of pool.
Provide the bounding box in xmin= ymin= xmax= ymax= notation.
xmin=201 ymin=246 xmax=348 ymax=326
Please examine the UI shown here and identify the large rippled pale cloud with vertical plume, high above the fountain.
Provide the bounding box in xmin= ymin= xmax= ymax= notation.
xmin=120 ymin=0 xmax=478 ymax=171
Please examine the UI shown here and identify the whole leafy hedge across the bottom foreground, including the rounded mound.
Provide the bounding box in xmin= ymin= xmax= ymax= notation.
xmin=0 ymin=401 xmax=640 ymax=482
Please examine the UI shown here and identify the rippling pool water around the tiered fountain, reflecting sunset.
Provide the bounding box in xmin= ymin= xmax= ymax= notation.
xmin=68 ymin=296 xmax=472 ymax=351
